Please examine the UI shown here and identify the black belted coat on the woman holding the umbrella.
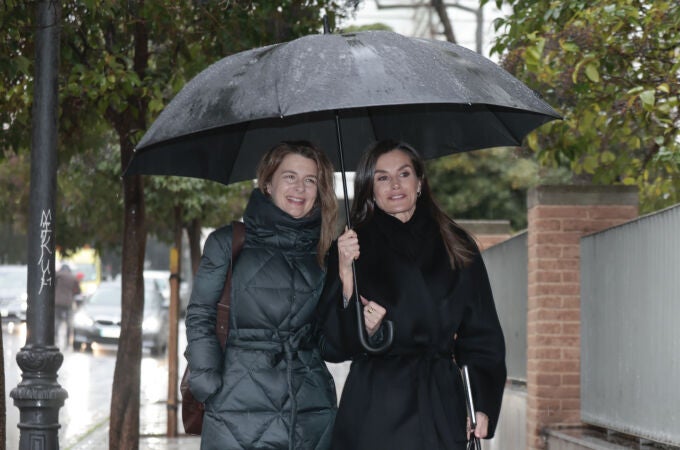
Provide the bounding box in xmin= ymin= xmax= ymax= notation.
xmin=319 ymin=207 xmax=506 ymax=450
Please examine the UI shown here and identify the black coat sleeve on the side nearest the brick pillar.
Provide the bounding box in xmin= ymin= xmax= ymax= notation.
xmin=455 ymin=254 xmax=507 ymax=438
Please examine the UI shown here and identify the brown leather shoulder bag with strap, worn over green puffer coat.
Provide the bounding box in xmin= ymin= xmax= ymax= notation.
xmin=179 ymin=221 xmax=246 ymax=435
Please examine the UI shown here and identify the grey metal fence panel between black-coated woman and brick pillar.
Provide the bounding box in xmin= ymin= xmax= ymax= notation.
xmin=482 ymin=231 xmax=528 ymax=382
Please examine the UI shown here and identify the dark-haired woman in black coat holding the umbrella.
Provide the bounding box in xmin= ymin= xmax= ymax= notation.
xmin=319 ymin=141 xmax=506 ymax=450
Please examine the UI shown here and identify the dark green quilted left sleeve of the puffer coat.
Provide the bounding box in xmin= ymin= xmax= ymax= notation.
xmin=185 ymin=226 xmax=231 ymax=402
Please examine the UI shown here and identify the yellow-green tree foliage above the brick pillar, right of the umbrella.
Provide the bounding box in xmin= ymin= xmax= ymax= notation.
xmin=484 ymin=0 xmax=680 ymax=212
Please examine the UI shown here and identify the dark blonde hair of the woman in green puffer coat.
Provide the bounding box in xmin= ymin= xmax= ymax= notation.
xmin=257 ymin=141 xmax=338 ymax=266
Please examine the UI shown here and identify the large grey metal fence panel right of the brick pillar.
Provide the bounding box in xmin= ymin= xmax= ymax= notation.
xmin=581 ymin=205 xmax=680 ymax=445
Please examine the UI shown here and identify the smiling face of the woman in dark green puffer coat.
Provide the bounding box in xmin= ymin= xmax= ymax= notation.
xmin=266 ymin=153 xmax=318 ymax=219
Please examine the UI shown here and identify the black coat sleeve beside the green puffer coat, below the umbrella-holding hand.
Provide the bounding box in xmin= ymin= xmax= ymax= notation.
xmin=316 ymin=242 xmax=362 ymax=362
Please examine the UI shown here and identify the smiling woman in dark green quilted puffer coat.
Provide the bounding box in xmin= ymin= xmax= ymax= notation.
xmin=186 ymin=142 xmax=337 ymax=450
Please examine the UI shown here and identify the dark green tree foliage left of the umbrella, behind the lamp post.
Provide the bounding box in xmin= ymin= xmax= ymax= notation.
xmin=0 ymin=0 xmax=344 ymax=253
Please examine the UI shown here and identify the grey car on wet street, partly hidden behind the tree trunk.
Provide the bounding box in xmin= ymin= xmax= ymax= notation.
xmin=73 ymin=280 xmax=169 ymax=355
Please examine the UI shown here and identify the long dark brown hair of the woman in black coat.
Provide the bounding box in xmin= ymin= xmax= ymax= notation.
xmin=351 ymin=139 xmax=477 ymax=269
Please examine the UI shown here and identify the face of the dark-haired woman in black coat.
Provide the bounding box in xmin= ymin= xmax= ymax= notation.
xmin=373 ymin=150 xmax=421 ymax=222
